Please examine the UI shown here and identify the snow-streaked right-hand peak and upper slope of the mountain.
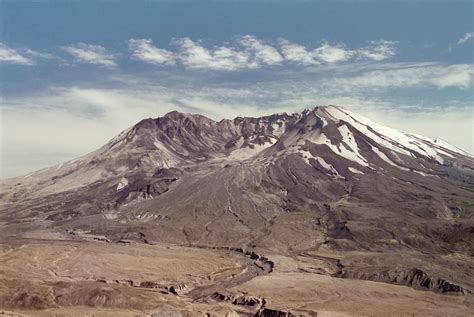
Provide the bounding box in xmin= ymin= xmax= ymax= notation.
xmin=260 ymin=106 xmax=473 ymax=177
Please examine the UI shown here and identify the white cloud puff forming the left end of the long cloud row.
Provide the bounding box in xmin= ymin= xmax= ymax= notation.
xmin=128 ymin=39 xmax=175 ymax=65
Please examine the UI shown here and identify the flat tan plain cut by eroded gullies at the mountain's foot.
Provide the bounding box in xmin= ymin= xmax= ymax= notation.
xmin=0 ymin=239 xmax=474 ymax=316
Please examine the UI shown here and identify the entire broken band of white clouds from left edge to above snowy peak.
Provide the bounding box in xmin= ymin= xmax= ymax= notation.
xmin=0 ymin=35 xmax=396 ymax=71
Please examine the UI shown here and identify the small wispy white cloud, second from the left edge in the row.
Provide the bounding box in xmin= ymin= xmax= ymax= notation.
xmin=62 ymin=43 xmax=117 ymax=68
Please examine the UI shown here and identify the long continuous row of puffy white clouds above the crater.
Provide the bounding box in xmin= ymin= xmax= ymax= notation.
xmin=129 ymin=35 xmax=396 ymax=71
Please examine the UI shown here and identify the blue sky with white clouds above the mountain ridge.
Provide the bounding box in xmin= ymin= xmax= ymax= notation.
xmin=0 ymin=0 xmax=474 ymax=178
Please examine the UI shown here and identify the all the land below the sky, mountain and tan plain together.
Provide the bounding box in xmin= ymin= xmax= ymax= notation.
xmin=0 ymin=106 xmax=474 ymax=316
